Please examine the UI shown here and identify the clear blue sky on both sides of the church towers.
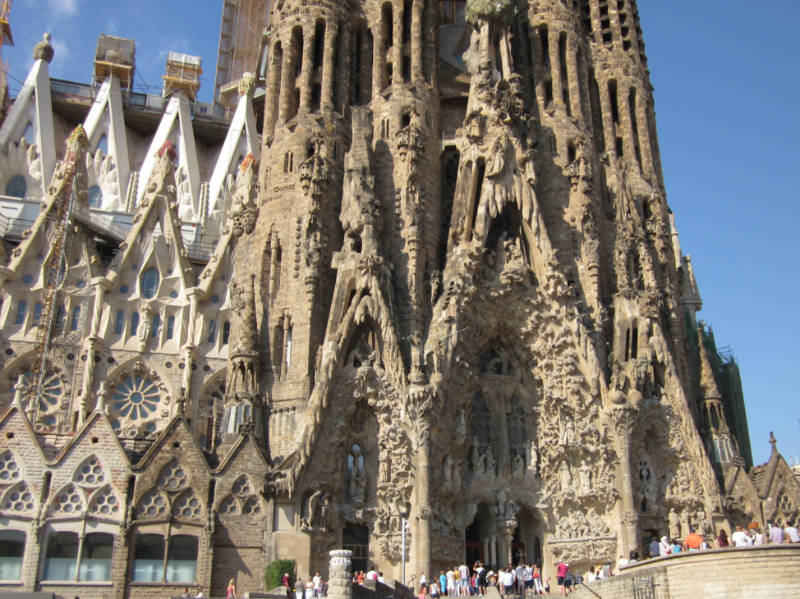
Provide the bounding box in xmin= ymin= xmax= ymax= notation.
xmin=3 ymin=0 xmax=800 ymax=463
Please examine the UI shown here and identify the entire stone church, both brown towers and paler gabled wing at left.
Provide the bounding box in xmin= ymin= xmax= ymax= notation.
xmin=0 ymin=0 xmax=800 ymax=598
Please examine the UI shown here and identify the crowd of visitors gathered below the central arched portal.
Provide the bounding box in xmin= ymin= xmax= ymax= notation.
xmin=419 ymin=561 xmax=550 ymax=599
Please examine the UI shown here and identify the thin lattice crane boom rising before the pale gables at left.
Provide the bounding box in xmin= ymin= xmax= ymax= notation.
xmin=25 ymin=147 xmax=78 ymax=423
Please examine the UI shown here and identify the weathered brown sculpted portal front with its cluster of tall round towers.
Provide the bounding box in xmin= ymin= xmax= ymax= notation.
xmin=230 ymin=0 xmax=726 ymax=576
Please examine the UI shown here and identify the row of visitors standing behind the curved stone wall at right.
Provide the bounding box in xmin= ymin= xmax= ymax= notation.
xmin=644 ymin=522 xmax=800 ymax=565
